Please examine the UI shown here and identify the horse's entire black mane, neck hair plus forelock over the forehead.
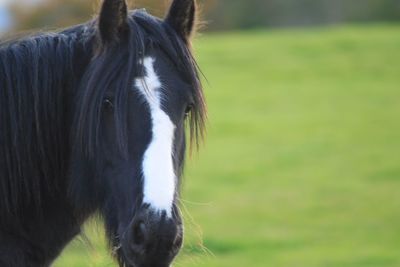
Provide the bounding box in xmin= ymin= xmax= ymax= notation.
xmin=0 ymin=11 xmax=205 ymax=220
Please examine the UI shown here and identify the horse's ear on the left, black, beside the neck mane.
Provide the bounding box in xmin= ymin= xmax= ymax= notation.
xmin=99 ymin=0 xmax=128 ymax=43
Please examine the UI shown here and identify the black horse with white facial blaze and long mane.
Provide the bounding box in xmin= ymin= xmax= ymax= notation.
xmin=0 ymin=0 xmax=206 ymax=267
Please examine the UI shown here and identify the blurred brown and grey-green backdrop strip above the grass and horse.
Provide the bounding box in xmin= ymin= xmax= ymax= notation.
xmin=0 ymin=0 xmax=400 ymax=31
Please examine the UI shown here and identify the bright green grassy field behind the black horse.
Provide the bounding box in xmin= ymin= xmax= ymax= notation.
xmin=55 ymin=25 xmax=400 ymax=267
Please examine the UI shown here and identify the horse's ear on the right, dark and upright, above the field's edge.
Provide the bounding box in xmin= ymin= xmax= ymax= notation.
xmin=165 ymin=0 xmax=196 ymax=42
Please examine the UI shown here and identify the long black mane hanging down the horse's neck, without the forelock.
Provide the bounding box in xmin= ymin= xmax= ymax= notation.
xmin=0 ymin=27 xmax=94 ymax=216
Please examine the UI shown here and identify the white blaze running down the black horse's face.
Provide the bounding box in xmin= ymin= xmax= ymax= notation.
xmin=135 ymin=57 xmax=176 ymax=217
